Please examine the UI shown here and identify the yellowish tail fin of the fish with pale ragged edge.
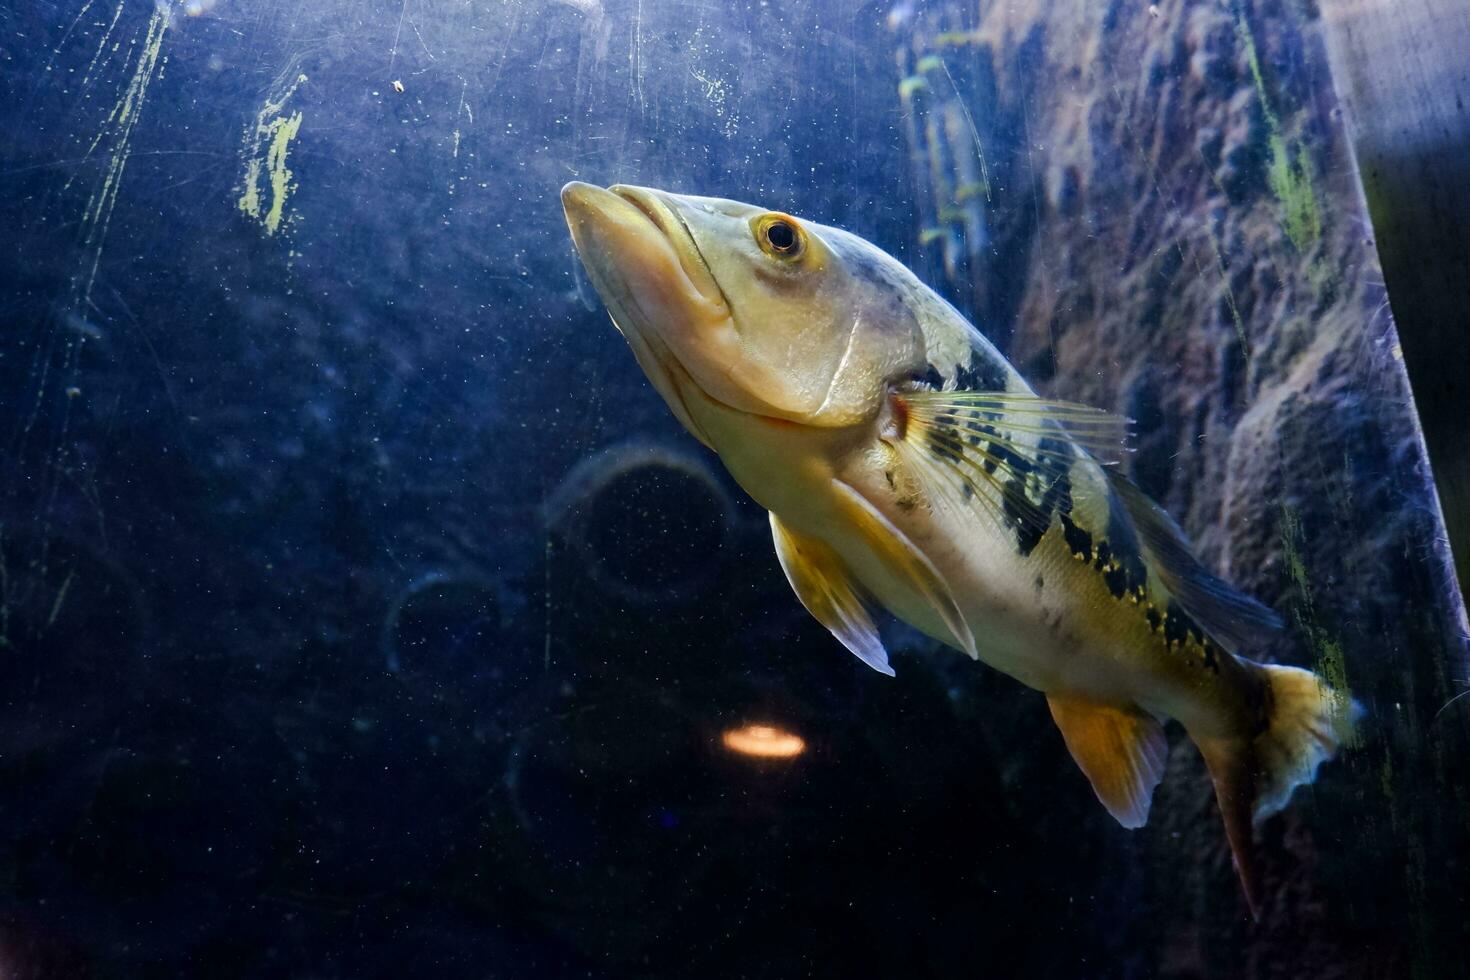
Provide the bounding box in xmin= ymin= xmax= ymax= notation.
xmin=1200 ymin=664 xmax=1361 ymax=917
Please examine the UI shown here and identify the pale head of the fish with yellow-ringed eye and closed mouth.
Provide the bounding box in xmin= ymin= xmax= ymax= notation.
xmin=562 ymin=182 xmax=925 ymax=437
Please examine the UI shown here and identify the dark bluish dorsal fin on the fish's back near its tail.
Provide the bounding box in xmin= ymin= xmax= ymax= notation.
xmin=1104 ymin=469 xmax=1282 ymax=652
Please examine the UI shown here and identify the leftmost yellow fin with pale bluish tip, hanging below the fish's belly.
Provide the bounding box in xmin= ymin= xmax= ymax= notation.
xmin=770 ymin=514 xmax=894 ymax=677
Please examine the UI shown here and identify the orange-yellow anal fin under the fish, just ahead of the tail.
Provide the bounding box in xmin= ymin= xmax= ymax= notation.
xmin=1047 ymin=695 xmax=1169 ymax=830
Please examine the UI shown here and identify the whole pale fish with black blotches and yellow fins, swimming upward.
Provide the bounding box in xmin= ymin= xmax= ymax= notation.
xmin=562 ymin=181 xmax=1361 ymax=915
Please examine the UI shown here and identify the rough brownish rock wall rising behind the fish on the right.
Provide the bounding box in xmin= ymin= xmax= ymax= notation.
xmin=899 ymin=0 xmax=1470 ymax=977
